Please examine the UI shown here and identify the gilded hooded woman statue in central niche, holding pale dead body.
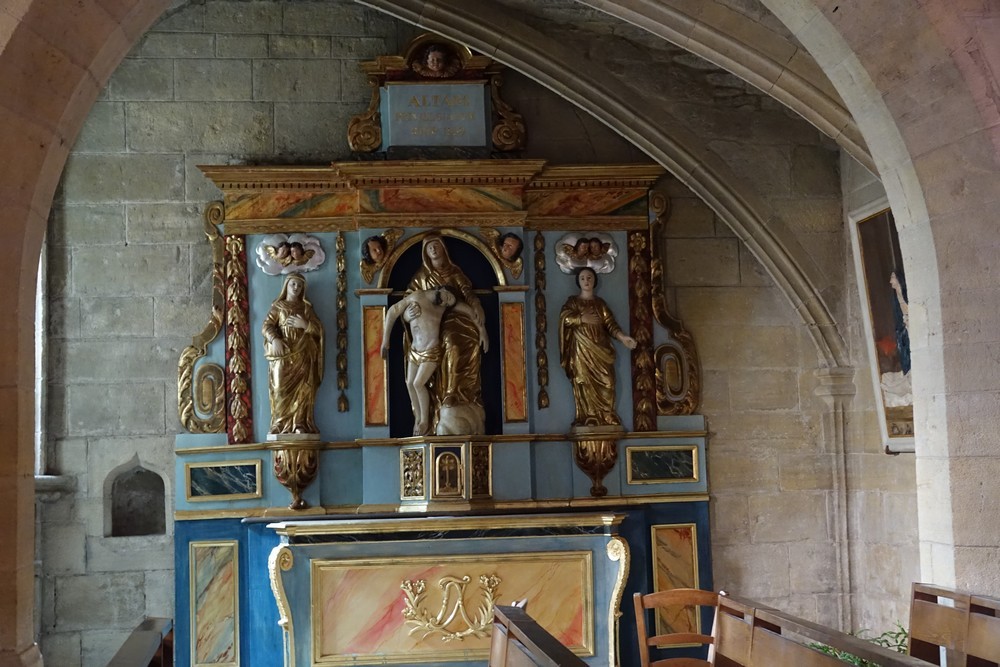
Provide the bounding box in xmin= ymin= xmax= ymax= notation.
xmin=407 ymin=234 xmax=486 ymax=435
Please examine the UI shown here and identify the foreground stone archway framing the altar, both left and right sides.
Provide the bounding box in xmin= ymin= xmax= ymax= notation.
xmin=0 ymin=0 xmax=1000 ymax=667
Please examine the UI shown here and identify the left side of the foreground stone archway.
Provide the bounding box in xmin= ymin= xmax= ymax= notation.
xmin=0 ymin=0 xmax=169 ymax=667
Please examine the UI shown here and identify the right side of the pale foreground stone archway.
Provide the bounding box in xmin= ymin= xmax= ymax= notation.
xmin=763 ymin=0 xmax=1000 ymax=593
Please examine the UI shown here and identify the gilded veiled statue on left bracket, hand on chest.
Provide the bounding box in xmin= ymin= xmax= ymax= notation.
xmin=261 ymin=273 xmax=323 ymax=435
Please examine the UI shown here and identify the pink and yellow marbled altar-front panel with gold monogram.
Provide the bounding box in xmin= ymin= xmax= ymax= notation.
xmin=312 ymin=552 xmax=594 ymax=665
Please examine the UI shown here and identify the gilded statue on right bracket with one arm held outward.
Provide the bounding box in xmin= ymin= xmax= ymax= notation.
xmin=559 ymin=267 xmax=636 ymax=426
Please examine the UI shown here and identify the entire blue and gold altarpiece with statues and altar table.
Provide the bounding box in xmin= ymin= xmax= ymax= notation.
xmin=175 ymin=36 xmax=711 ymax=667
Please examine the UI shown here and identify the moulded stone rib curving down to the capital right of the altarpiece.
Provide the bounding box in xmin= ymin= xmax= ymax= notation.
xmin=362 ymin=0 xmax=848 ymax=367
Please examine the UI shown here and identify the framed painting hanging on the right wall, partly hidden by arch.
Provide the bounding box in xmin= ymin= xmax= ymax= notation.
xmin=853 ymin=208 xmax=914 ymax=453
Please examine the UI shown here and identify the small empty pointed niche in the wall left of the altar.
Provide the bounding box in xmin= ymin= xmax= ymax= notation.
xmin=111 ymin=465 xmax=166 ymax=537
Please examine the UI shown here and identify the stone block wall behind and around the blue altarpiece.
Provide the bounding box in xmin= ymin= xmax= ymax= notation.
xmin=39 ymin=0 xmax=916 ymax=667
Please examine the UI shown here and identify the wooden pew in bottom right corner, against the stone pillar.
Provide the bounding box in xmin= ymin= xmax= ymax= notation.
xmin=910 ymin=583 xmax=1000 ymax=667
